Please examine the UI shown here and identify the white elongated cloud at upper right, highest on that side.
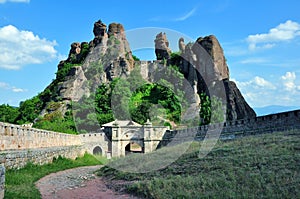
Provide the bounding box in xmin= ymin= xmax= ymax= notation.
xmin=247 ymin=20 xmax=300 ymax=50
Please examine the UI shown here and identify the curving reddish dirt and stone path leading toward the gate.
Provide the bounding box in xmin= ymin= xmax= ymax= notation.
xmin=36 ymin=166 xmax=136 ymax=199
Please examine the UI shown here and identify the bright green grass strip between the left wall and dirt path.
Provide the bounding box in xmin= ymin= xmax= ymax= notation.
xmin=5 ymin=154 xmax=105 ymax=199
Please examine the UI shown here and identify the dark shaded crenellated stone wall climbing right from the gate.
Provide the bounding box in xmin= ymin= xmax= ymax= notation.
xmin=158 ymin=110 xmax=300 ymax=148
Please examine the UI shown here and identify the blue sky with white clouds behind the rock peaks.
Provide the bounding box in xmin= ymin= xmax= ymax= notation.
xmin=0 ymin=0 xmax=300 ymax=113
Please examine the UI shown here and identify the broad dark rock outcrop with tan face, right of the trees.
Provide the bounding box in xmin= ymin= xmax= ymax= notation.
xmin=178 ymin=35 xmax=256 ymax=120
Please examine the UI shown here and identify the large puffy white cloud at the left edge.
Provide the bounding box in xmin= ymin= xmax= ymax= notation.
xmin=0 ymin=25 xmax=58 ymax=70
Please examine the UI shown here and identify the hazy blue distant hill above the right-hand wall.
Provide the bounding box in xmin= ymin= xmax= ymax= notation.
xmin=253 ymin=105 xmax=300 ymax=116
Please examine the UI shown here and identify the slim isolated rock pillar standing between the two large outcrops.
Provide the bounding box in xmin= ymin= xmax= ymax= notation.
xmin=154 ymin=32 xmax=171 ymax=60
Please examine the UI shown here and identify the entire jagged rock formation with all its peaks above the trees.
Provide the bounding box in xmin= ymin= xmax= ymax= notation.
xmin=41 ymin=20 xmax=255 ymax=123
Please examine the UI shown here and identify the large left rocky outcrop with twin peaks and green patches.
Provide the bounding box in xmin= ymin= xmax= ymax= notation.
xmin=41 ymin=20 xmax=134 ymax=116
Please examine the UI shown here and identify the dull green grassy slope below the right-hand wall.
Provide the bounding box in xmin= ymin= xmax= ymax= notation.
xmin=98 ymin=131 xmax=300 ymax=198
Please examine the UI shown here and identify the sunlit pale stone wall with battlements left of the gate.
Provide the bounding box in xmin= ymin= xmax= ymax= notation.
xmin=0 ymin=122 xmax=107 ymax=199
